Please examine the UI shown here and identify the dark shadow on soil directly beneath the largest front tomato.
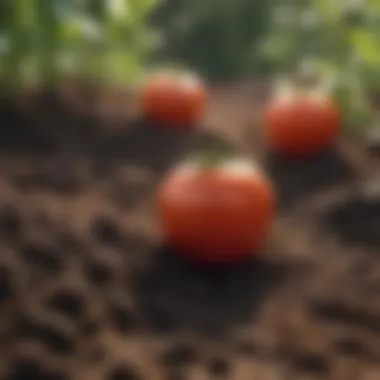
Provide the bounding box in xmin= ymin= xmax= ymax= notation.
xmin=134 ymin=248 xmax=288 ymax=338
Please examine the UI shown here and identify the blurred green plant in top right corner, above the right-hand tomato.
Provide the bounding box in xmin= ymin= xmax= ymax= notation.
xmin=258 ymin=0 xmax=380 ymax=133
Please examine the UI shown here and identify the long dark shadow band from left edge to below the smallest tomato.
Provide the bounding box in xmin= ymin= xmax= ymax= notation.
xmin=0 ymin=93 xmax=235 ymax=180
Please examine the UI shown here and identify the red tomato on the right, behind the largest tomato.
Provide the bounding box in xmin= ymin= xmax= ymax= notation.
xmin=263 ymin=93 xmax=340 ymax=157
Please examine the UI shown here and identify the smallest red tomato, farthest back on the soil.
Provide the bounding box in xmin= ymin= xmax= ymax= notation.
xmin=141 ymin=73 xmax=207 ymax=125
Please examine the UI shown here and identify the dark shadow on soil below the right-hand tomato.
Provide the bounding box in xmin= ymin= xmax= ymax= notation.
xmin=266 ymin=147 xmax=353 ymax=209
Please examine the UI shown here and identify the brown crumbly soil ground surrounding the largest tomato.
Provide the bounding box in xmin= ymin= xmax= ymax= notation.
xmin=0 ymin=81 xmax=380 ymax=380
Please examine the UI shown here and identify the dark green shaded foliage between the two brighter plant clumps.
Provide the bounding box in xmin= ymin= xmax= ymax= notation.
xmin=151 ymin=0 xmax=270 ymax=79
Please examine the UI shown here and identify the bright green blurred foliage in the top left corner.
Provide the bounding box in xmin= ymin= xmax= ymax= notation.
xmin=0 ymin=0 xmax=159 ymax=85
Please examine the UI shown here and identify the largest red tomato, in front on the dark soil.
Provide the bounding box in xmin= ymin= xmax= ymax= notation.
xmin=156 ymin=160 xmax=275 ymax=263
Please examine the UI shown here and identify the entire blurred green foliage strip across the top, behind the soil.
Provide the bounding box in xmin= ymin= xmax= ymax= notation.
xmin=0 ymin=0 xmax=380 ymax=129
